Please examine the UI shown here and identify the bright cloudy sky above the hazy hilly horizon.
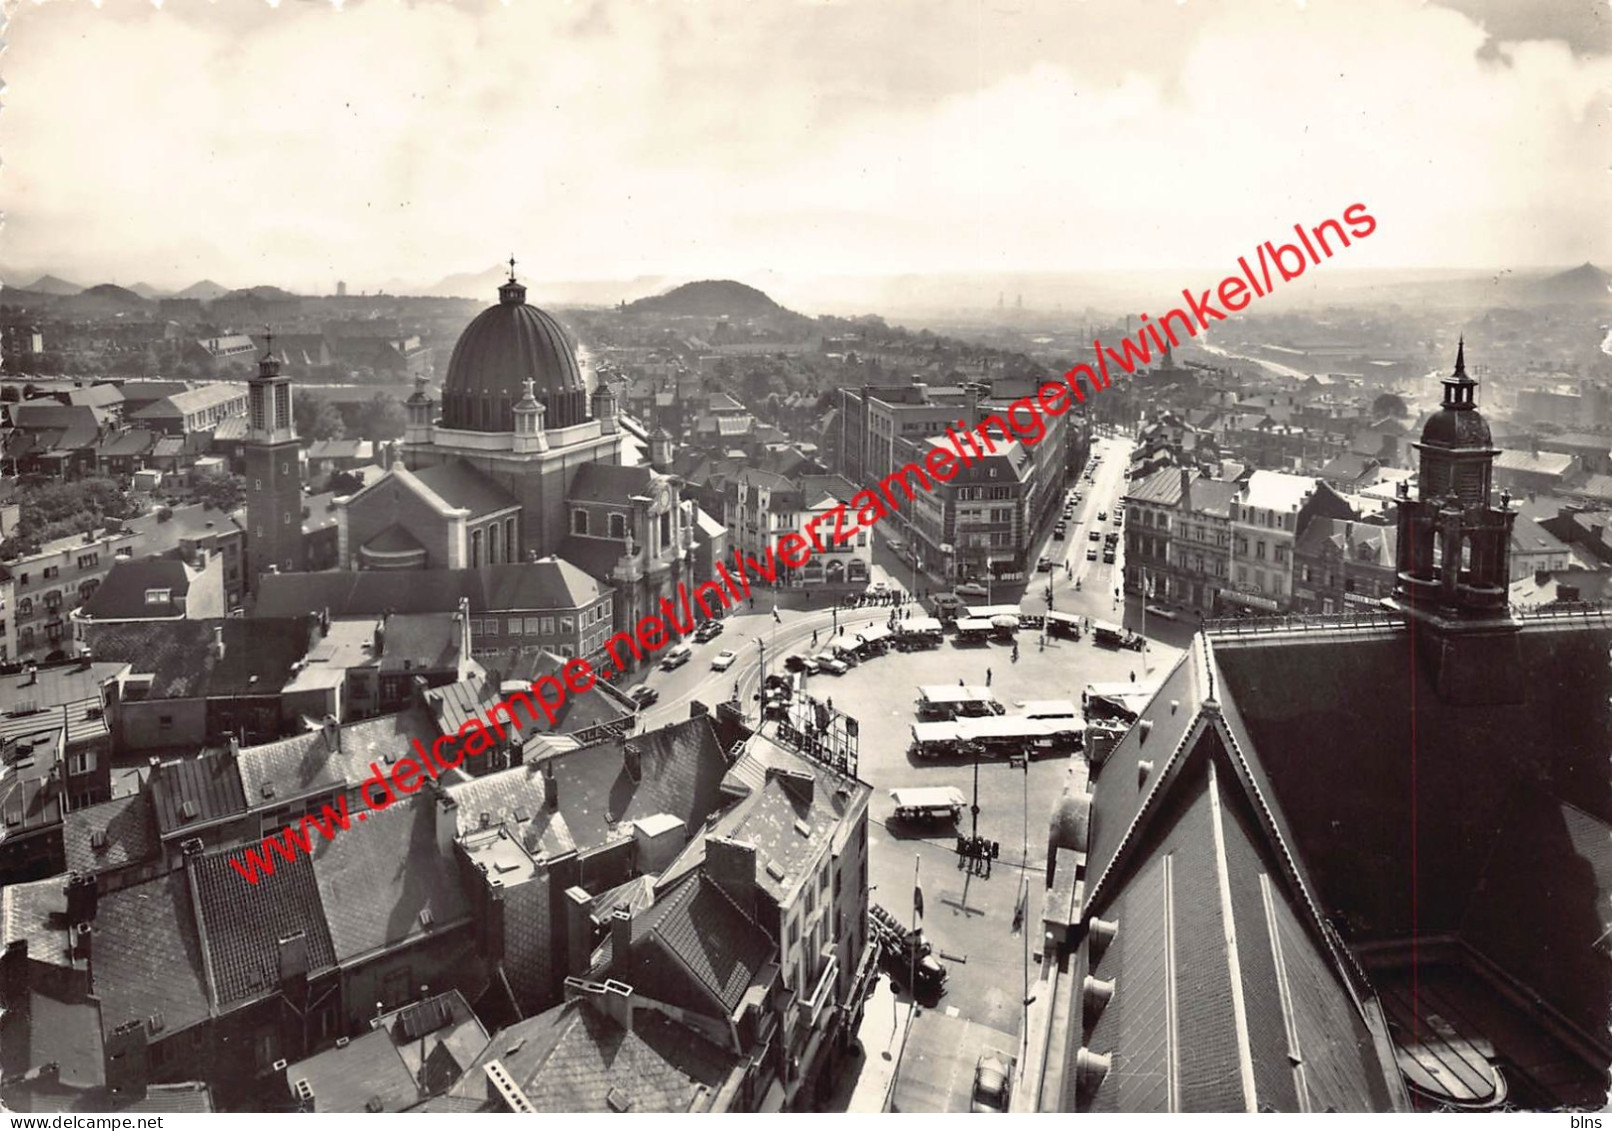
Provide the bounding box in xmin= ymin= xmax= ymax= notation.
xmin=0 ymin=0 xmax=1612 ymax=292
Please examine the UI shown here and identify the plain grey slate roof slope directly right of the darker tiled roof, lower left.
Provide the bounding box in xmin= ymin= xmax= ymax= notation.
xmin=307 ymin=794 xmax=469 ymax=962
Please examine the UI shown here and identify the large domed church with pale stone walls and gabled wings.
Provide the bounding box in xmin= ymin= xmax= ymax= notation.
xmin=337 ymin=261 xmax=712 ymax=663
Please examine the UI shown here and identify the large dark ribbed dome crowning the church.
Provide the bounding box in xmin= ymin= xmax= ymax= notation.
xmin=442 ymin=279 xmax=590 ymax=432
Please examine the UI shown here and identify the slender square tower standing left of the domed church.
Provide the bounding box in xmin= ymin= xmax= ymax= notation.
xmin=247 ymin=335 xmax=305 ymax=578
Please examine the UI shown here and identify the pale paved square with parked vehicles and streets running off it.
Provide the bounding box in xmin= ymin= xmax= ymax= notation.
xmin=619 ymin=438 xmax=1191 ymax=1110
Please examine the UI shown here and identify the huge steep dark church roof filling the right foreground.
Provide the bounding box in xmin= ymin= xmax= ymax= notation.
xmin=1064 ymin=617 xmax=1612 ymax=1110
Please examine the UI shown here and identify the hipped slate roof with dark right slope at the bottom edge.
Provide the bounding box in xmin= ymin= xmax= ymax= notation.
xmin=450 ymin=1001 xmax=735 ymax=1112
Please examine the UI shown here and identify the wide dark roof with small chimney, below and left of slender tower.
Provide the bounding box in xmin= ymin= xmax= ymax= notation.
xmin=93 ymin=617 xmax=310 ymax=699
